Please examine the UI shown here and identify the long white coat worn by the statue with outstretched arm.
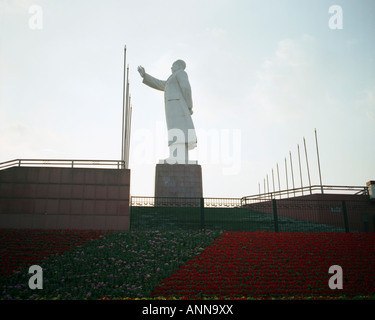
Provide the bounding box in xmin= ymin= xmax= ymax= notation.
xmin=143 ymin=70 xmax=197 ymax=149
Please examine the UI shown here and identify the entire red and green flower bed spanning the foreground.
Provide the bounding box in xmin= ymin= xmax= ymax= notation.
xmin=0 ymin=230 xmax=375 ymax=299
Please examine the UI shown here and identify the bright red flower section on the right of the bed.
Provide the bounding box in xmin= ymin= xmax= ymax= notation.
xmin=152 ymin=232 xmax=375 ymax=299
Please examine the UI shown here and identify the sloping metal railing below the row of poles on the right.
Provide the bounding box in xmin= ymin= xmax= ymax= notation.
xmin=241 ymin=185 xmax=369 ymax=205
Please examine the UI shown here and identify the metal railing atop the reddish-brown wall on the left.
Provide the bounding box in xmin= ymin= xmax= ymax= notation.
xmin=0 ymin=159 xmax=125 ymax=170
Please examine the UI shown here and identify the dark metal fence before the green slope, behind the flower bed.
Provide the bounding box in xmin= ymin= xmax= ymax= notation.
xmin=130 ymin=197 xmax=375 ymax=232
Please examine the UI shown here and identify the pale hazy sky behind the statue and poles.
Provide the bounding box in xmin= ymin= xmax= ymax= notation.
xmin=0 ymin=0 xmax=375 ymax=197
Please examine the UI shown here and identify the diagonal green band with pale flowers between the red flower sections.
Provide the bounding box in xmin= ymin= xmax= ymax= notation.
xmin=0 ymin=231 xmax=220 ymax=299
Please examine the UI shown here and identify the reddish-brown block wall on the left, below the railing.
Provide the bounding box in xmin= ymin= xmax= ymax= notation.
xmin=0 ymin=167 xmax=130 ymax=230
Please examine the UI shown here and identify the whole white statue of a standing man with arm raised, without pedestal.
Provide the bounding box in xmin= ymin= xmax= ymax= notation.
xmin=138 ymin=60 xmax=197 ymax=164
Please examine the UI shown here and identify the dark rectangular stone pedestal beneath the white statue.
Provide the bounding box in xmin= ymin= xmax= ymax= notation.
xmin=155 ymin=164 xmax=203 ymax=198
